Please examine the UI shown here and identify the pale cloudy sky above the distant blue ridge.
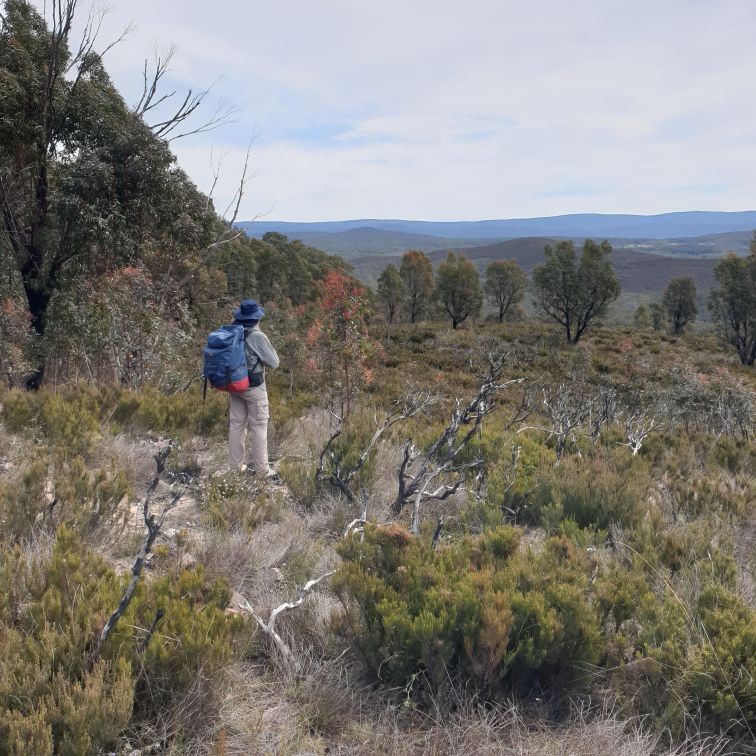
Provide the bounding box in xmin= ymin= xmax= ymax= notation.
xmin=32 ymin=0 xmax=756 ymax=221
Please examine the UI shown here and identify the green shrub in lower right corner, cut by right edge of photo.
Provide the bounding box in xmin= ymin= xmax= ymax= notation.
xmin=595 ymin=544 xmax=756 ymax=737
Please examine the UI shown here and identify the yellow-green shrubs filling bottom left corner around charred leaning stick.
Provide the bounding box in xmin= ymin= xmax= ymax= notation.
xmin=0 ymin=528 xmax=238 ymax=756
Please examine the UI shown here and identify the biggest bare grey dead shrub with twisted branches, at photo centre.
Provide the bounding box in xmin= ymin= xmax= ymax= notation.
xmin=392 ymin=351 xmax=521 ymax=535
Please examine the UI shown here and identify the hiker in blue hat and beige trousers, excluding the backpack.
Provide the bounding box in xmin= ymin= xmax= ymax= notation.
xmin=228 ymin=299 xmax=280 ymax=483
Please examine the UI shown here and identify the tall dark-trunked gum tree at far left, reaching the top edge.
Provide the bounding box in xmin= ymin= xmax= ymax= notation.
xmin=0 ymin=0 xmax=230 ymax=387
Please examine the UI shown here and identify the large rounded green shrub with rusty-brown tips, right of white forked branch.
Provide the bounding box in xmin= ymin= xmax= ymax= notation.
xmin=334 ymin=526 xmax=600 ymax=686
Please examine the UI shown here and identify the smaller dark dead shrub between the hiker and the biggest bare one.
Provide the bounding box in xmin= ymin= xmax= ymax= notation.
xmin=315 ymin=389 xmax=436 ymax=503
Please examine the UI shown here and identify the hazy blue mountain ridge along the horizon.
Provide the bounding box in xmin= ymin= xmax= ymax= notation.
xmin=237 ymin=210 xmax=756 ymax=240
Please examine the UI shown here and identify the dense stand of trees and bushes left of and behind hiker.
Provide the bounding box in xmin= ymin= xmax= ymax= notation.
xmin=0 ymin=1 xmax=342 ymax=386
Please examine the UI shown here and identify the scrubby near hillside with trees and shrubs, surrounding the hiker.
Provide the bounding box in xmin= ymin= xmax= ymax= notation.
xmin=0 ymin=0 xmax=756 ymax=756
